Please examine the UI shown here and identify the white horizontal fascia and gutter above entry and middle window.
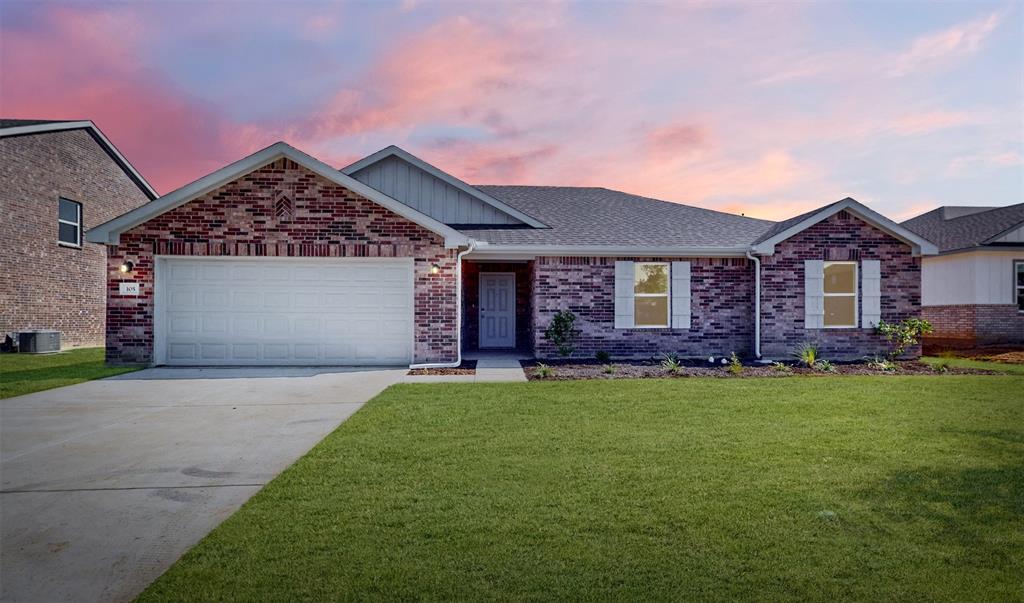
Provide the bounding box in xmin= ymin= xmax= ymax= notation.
xmin=466 ymin=243 xmax=750 ymax=259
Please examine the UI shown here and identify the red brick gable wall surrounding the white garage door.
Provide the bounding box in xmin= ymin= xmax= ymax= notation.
xmin=106 ymin=160 xmax=456 ymax=362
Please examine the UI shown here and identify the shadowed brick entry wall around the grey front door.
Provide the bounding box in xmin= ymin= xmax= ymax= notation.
xmin=462 ymin=261 xmax=534 ymax=351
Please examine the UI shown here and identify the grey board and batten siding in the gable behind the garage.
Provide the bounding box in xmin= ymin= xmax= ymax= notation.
xmin=351 ymin=157 xmax=521 ymax=224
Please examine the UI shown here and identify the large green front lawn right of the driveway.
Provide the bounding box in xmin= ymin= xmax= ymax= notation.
xmin=141 ymin=376 xmax=1024 ymax=601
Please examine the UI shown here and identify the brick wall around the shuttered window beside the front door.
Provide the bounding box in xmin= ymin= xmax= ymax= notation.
xmin=532 ymin=257 xmax=754 ymax=358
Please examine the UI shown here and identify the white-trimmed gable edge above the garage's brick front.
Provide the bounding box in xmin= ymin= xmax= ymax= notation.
xmin=86 ymin=142 xmax=468 ymax=248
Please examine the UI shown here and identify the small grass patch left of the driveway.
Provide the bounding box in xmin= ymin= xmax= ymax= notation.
xmin=0 ymin=348 xmax=138 ymax=398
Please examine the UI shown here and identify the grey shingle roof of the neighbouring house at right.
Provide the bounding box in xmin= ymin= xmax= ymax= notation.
xmin=903 ymin=203 xmax=1024 ymax=253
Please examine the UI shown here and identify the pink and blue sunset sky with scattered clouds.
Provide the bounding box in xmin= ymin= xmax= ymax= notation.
xmin=0 ymin=0 xmax=1024 ymax=219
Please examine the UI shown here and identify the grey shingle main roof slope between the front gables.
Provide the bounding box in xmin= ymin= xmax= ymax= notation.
xmin=459 ymin=185 xmax=774 ymax=248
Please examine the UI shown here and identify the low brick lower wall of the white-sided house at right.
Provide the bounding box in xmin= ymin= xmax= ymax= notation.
xmin=921 ymin=304 xmax=1024 ymax=346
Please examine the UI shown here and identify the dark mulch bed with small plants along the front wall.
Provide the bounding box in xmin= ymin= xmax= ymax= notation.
xmin=522 ymin=360 xmax=994 ymax=381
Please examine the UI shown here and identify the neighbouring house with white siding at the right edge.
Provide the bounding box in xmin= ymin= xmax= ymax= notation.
xmin=903 ymin=203 xmax=1024 ymax=346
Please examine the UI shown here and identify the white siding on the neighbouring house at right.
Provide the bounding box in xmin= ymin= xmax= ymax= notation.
xmin=921 ymin=250 xmax=1024 ymax=306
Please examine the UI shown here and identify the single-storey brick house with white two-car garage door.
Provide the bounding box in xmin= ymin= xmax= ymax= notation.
xmin=88 ymin=142 xmax=937 ymax=365
